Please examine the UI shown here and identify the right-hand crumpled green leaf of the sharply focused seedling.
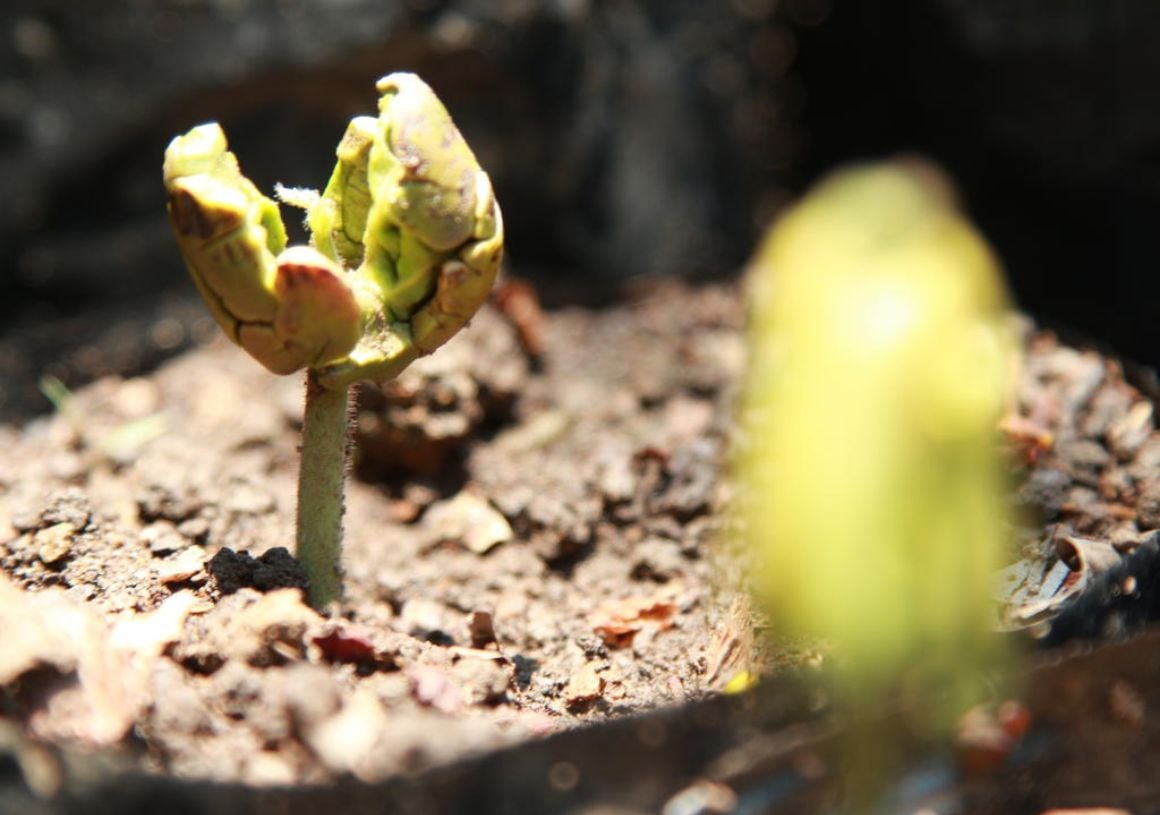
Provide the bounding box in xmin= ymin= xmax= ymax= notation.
xmin=311 ymin=73 xmax=503 ymax=387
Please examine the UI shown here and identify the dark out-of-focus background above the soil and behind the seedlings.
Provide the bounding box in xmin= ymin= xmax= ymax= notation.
xmin=0 ymin=0 xmax=1160 ymax=419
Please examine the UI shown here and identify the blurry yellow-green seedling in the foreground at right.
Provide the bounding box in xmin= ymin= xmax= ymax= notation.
xmin=738 ymin=162 xmax=1013 ymax=802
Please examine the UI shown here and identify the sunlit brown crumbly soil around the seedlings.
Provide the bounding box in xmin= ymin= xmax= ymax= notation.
xmin=0 ymin=283 xmax=1160 ymax=812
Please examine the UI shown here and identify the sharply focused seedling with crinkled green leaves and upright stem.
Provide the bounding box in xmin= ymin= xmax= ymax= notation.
xmin=164 ymin=73 xmax=503 ymax=607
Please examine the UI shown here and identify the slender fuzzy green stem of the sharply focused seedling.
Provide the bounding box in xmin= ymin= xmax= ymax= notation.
xmin=298 ymin=371 xmax=349 ymax=610
